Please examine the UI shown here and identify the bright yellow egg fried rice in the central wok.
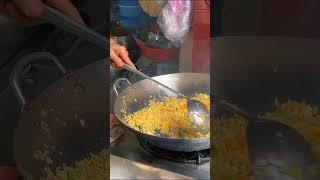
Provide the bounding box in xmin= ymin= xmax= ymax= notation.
xmin=125 ymin=94 xmax=210 ymax=138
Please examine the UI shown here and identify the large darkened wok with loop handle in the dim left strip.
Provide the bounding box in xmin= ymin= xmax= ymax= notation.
xmin=11 ymin=53 xmax=109 ymax=179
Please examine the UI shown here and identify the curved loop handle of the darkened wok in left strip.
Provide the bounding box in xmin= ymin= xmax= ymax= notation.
xmin=10 ymin=52 xmax=67 ymax=111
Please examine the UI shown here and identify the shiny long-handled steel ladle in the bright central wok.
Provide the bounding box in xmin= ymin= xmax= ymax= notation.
xmin=123 ymin=64 xmax=210 ymax=131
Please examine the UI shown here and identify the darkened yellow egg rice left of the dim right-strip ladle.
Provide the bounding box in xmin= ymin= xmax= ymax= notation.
xmin=210 ymin=115 xmax=254 ymax=180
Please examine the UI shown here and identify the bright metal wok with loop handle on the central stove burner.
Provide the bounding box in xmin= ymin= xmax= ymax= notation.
xmin=113 ymin=73 xmax=210 ymax=152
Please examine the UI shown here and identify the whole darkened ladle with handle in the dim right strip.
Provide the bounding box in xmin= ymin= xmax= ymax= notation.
xmin=216 ymin=100 xmax=314 ymax=179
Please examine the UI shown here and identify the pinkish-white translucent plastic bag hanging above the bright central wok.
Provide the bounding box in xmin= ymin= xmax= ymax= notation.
xmin=157 ymin=0 xmax=191 ymax=42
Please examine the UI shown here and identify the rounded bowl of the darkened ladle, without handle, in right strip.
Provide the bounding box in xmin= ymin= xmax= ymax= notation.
xmin=247 ymin=122 xmax=319 ymax=180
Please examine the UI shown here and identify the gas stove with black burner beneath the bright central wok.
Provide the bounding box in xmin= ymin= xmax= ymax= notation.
xmin=110 ymin=127 xmax=210 ymax=179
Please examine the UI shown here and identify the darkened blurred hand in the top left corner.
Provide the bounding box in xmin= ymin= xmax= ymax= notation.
xmin=0 ymin=0 xmax=84 ymax=24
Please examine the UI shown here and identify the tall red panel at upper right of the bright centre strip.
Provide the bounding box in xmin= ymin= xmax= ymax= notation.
xmin=191 ymin=1 xmax=210 ymax=73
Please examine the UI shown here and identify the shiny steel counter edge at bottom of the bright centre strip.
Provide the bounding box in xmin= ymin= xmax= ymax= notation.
xmin=110 ymin=155 xmax=193 ymax=180
